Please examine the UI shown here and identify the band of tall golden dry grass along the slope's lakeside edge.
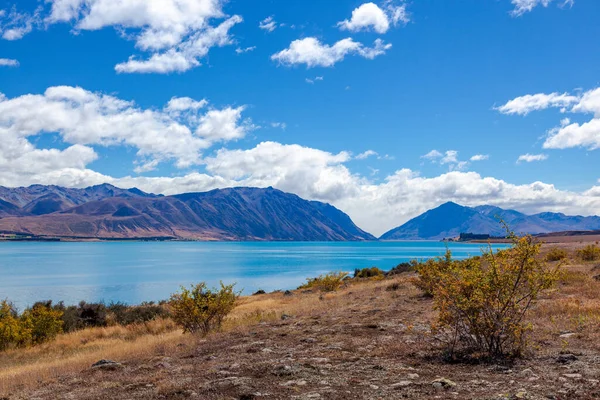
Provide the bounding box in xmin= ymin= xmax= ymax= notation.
xmin=0 ymin=281 xmax=389 ymax=395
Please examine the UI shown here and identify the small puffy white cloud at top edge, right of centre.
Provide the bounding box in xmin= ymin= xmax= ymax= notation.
xmin=337 ymin=1 xmax=410 ymax=34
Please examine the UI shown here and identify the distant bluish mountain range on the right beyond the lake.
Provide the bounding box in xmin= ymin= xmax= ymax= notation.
xmin=380 ymin=202 xmax=600 ymax=240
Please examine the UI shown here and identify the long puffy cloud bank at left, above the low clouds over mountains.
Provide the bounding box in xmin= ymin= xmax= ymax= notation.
xmin=0 ymin=86 xmax=252 ymax=170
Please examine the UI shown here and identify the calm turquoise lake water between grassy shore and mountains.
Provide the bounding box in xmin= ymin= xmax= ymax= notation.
xmin=0 ymin=242 xmax=503 ymax=309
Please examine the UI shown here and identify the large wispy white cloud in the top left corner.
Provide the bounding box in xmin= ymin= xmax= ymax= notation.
xmin=2 ymin=0 xmax=242 ymax=73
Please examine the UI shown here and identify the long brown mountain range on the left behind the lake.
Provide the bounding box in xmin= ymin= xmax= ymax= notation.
xmin=0 ymin=184 xmax=375 ymax=241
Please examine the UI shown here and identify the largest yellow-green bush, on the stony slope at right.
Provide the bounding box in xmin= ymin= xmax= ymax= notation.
xmin=415 ymin=235 xmax=560 ymax=358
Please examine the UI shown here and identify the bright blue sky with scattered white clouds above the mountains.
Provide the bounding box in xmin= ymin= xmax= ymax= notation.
xmin=0 ymin=0 xmax=600 ymax=235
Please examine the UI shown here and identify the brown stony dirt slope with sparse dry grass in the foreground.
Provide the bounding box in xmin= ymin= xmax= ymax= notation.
xmin=0 ymin=244 xmax=600 ymax=400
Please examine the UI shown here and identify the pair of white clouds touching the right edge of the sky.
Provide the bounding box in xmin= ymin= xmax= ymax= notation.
xmin=498 ymin=88 xmax=600 ymax=150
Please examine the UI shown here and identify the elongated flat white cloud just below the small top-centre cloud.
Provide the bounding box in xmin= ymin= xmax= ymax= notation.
xmin=271 ymin=37 xmax=392 ymax=68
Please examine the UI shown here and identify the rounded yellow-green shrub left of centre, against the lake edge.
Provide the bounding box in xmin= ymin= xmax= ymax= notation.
xmin=170 ymin=282 xmax=239 ymax=335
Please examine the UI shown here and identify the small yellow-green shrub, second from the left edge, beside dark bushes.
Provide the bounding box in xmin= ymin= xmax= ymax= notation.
xmin=21 ymin=301 xmax=64 ymax=345
